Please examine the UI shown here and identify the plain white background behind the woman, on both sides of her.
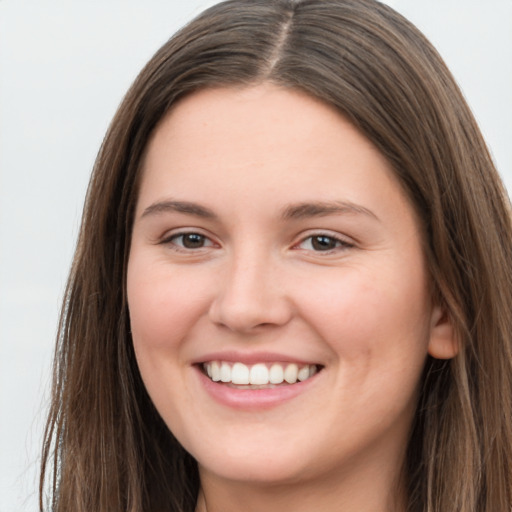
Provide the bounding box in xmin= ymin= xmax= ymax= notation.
xmin=0 ymin=0 xmax=512 ymax=512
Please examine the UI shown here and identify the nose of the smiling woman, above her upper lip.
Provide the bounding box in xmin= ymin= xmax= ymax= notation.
xmin=209 ymin=254 xmax=293 ymax=333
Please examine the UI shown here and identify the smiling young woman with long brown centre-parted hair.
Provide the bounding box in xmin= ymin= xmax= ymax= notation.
xmin=41 ymin=0 xmax=512 ymax=512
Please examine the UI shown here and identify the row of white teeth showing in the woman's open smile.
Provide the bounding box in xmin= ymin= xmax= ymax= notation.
xmin=201 ymin=361 xmax=321 ymax=389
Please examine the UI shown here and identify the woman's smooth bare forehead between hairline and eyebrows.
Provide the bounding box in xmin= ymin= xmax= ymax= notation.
xmin=143 ymin=84 xmax=400 ymax=203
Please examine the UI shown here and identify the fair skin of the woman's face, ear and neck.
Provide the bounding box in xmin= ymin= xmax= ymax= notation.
xmin=127 ymin=84 xmax=456 ymax=512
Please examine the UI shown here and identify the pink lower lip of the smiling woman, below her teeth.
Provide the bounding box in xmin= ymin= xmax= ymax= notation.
xmin=196 ymin=367 xmax=320 ymax=410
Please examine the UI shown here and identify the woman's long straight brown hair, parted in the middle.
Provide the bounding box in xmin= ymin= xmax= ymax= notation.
xmin=40 ymin=0 xmax=512 ymax=512
